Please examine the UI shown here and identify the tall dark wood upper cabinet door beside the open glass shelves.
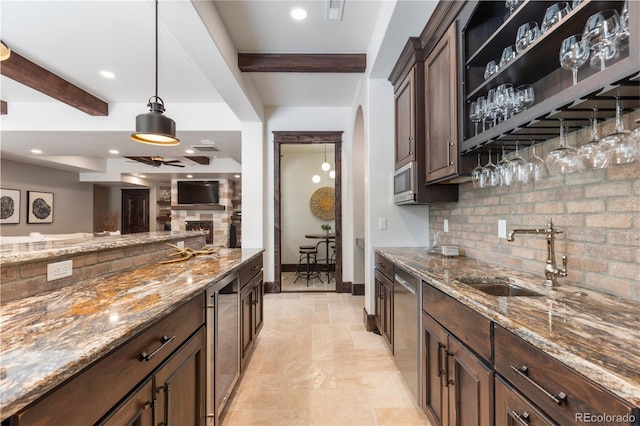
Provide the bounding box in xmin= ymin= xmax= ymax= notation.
xmin=425 ymin=21 xmax=458 ymax=182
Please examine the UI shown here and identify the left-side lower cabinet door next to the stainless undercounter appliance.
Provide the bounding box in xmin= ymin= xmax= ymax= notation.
xmin=153 ymin=327 xmax=206 ymax=426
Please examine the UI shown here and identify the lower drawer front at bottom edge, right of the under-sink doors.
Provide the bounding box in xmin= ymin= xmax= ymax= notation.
xmin=495 ymin=377 xmax=557 ymax=426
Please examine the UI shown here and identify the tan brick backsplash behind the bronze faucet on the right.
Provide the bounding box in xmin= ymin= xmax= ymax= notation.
xmin=429 ymin=111 xmax=640 ymax=301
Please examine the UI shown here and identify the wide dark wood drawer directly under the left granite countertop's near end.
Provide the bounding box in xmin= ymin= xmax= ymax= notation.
xmin=18 ymin=296 xmax=204 ymax=426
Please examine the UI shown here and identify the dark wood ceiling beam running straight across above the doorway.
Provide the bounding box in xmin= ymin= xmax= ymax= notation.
xmin=238 ymin=53 xmax=367 ymax=73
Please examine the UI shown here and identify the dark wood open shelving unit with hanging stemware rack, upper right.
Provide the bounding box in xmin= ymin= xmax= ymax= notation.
xmin=460 ymin=0 xmax=640 ymax=155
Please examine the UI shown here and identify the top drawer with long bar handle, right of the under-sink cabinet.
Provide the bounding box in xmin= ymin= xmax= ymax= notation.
xmin=494 ymin=325 xmax=633 ymax=424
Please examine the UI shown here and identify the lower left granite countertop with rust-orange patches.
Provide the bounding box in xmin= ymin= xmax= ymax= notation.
xmin=0 ymin=246 xmax=263 ymax=420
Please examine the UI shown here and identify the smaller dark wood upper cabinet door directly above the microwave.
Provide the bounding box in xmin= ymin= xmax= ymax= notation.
xmin=395 ymin=68 xmax=416 ymax=170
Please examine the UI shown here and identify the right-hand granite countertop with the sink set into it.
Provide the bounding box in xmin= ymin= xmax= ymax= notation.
xmin=375 ymin=247 xmax=640 ymax=407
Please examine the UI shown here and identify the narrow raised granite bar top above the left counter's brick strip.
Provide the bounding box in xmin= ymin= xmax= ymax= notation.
xmin=0 ymin=231 xmax=204 ymax=265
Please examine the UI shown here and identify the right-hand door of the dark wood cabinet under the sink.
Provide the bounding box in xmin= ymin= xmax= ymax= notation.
xmin=445 ymin=335 xmax=493 ymax=426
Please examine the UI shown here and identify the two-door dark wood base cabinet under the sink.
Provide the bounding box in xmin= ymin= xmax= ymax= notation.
xmin=422 ymin=313 xmax=493 ymax=426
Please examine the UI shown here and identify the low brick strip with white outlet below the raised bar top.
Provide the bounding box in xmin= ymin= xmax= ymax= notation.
xmin=0 ymin=236 xmax=204 ymax=303
